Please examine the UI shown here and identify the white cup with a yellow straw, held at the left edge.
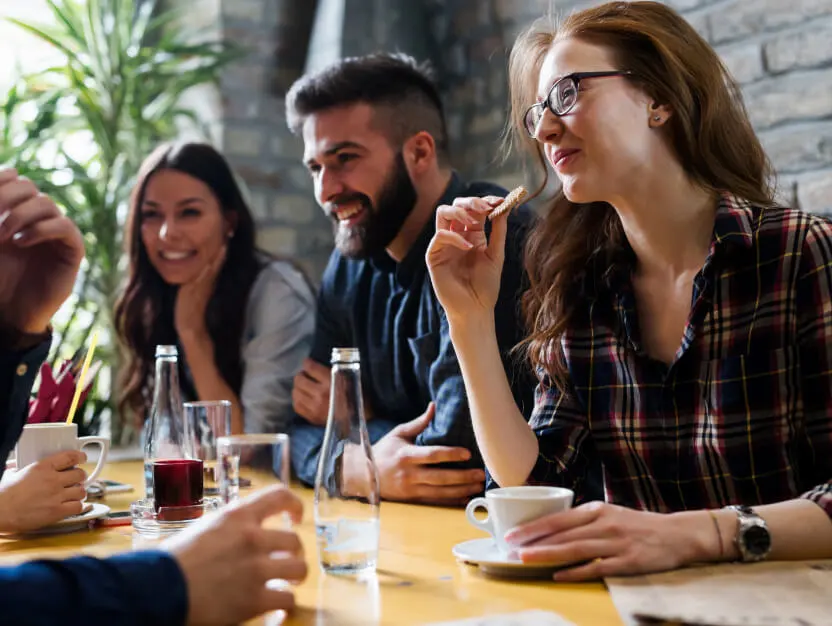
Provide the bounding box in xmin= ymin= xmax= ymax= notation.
xmin=15 ymin=423 xmax=110 ymax=487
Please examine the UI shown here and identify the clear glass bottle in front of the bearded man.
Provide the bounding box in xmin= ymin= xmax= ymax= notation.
xmin=315 ymin=348 xmax=381 ymax=574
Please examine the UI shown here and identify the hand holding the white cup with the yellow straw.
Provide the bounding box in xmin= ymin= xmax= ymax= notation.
xmin=0 ymin=450 xmax=87 ymax=533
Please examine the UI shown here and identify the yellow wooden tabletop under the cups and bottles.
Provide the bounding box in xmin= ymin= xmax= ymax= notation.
xmin=0 ymin=462 xmax=622 ymax=626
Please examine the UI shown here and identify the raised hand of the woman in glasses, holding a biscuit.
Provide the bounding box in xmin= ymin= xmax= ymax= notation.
xmin=425 ymin=196 xmax=508 ymax=319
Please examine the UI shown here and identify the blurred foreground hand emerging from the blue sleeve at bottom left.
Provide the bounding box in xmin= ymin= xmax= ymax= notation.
xmin=163 ymin=486 xmax=306 ymax=626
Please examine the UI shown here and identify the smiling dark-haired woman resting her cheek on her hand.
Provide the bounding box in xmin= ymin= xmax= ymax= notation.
xmin=115 ymin=143 xmax=315 ymax=433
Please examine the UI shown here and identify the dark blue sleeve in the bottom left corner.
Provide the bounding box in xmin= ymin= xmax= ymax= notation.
xmin=0 ymin=551 xmax=188 ymax=626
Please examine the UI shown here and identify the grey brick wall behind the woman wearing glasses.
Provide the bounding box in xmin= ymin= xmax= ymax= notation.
xmin=430 ymin=0 xmax=832 ymax=212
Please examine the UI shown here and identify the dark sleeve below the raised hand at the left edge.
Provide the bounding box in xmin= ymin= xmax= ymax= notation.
xmin=0 ymin=340 xmax=51 ymax=477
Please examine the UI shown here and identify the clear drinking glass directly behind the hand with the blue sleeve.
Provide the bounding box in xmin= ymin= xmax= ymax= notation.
xmin=217 ymin=433 xmax=290 ymax=504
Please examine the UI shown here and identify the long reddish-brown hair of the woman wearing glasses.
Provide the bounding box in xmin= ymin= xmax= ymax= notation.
xmin=509 ymin=2 xmax=773 ymax=389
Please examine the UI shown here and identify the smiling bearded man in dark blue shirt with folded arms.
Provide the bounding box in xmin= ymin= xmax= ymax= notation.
xmin=286 ymin=54 xmax=535 ymax=505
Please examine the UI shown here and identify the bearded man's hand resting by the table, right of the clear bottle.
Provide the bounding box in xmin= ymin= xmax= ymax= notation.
xmin=344 ymin=402 xmax=485 ymax=506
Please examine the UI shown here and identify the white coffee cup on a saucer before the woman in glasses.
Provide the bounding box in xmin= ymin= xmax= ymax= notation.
xmin=465 ymin=486 xmax=574 ymax=552
